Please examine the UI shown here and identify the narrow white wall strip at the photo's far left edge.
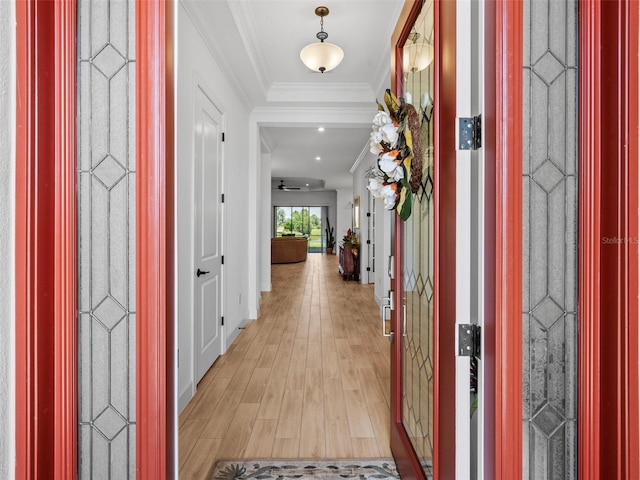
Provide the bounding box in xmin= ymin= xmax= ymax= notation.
xmin=0 ymin=2 xmax=16 ymax=479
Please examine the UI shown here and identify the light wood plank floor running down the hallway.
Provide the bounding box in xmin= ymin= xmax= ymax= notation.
xmin=179 ymin=254 xmax=391 ymax=480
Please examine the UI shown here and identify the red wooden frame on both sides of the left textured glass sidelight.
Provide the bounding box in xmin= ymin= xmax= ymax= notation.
xmin=15 ymin=0 xmax=177 ymax=480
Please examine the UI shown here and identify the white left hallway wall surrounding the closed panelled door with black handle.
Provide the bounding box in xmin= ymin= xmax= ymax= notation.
xmin=176 ymin=3 xmax=255 ymax=410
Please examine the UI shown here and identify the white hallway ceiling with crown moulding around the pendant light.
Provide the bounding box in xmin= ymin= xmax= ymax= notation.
xmin=183 ymin=0 xmax=404 ymax=190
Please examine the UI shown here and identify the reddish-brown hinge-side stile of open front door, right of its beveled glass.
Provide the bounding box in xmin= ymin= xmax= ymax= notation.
xmin=433 ymin=0 xmax=457 ymax=479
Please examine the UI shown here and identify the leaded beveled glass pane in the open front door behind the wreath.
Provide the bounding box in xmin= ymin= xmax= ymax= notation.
xmin=402 ymin=2 xmax=434 ymax=477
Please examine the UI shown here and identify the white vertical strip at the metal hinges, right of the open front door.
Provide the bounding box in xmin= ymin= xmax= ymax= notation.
xmin=455 ymin=1 xmax=484 ymax=480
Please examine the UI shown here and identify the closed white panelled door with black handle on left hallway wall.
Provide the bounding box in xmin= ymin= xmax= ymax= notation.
xmin=194 ymin=89 xmax=223 ymax=383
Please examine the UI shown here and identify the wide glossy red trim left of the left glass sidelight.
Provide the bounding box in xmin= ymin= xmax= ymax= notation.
xmin=16 ymin=1 xmax=77 ymax=479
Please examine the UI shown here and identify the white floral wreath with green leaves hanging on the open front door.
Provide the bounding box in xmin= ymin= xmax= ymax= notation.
xmin=367 ymin=89 xmax=422 ymax=220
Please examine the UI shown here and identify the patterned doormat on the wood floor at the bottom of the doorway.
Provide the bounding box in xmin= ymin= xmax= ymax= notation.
xmin=207 ymin=459 xmax=400 ymax=480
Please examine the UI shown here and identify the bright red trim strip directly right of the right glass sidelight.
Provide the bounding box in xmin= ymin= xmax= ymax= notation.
xmin=578 ymin=2 xmax=601 ymax=474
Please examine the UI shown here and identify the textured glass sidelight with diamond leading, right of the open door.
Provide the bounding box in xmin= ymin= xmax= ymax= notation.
xmin=522 ymin=0 xmax=578 ymax=479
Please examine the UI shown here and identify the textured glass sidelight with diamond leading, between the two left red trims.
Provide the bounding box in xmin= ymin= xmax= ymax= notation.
xmin=78 ymin=0 xmax=135 ymax=479
